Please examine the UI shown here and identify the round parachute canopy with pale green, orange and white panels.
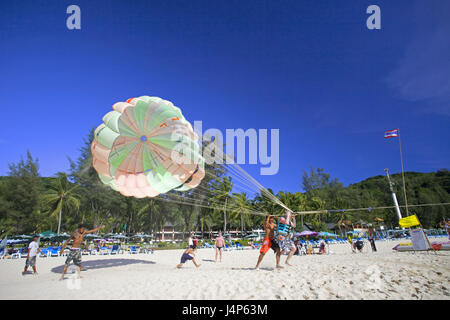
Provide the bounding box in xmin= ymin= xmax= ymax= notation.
xmin=91 ymin=96 xmax=205 ymax=198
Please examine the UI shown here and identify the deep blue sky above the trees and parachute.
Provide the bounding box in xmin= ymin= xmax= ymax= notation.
xmin=0 ymin=0 xmax=450 ymax=191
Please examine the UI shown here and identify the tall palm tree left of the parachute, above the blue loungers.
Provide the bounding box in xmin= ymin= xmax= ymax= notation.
xmin=43 ymin=172 xmax=80 ymax=234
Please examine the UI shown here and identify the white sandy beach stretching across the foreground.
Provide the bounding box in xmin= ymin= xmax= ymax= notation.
xmin=0 ymin=241 xmax=450 ymax=300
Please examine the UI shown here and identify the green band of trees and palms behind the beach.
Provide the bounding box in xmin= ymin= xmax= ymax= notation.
xmin=0 ymin=131 xmax=450 ymax=235
